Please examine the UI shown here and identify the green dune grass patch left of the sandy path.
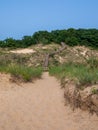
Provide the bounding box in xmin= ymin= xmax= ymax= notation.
xmin=0 ymin=64 xmax=42 ymax=81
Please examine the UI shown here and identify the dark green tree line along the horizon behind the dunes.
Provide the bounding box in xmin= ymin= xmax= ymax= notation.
xmin=0 ymin=28 xmax=98 ymax=48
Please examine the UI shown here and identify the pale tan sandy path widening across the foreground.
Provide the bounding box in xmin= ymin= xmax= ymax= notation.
xmin=0 ymin=73 xmax=98 ymax=130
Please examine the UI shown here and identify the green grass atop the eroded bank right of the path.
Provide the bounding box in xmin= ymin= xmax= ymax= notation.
xmin=49 ymin=63 xmax=98 ymax=86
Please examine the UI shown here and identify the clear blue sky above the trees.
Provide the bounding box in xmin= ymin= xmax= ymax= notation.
xmin=0 ymin=0 xmax=98 ymax=40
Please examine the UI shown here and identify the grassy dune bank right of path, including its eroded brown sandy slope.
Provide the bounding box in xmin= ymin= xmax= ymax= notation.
xmin=52 ymin=58 xmax=98 ymax=115
